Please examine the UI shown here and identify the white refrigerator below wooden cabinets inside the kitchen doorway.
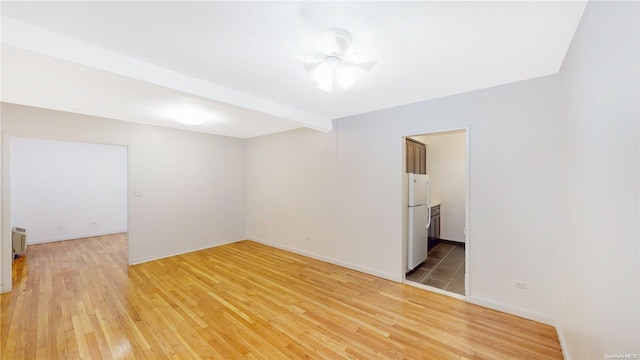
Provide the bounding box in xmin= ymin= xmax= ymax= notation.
xmin=407 ymin=174 xmax=431 ymax=271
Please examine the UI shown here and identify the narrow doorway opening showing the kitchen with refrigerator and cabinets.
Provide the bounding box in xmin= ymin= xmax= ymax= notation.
xmin=403 ymin=128 xmax=469 ymax=298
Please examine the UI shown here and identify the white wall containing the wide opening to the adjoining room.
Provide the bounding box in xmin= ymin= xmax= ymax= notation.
xmin=2 ymin=103 xmax=245 ymax=280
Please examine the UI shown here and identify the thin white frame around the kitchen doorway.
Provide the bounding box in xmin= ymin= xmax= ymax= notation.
xmin=400 ymin=126 xmax=473 ymax=301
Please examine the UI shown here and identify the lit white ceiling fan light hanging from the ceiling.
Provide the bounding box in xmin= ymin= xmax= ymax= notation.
xmin=304 ymin=28 xmax=376 ymax=92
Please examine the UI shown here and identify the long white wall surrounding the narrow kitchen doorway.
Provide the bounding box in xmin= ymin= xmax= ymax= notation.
xmin=246 ymin=73 xmax=562 ymax=322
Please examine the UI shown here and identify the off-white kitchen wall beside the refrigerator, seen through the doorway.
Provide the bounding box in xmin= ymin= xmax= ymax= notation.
xmin=414 ymin=131 xmax=467 ymax=242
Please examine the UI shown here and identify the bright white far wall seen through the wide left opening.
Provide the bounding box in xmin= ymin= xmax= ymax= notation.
xmin=10 ymin=137 xmax=127 ymax=244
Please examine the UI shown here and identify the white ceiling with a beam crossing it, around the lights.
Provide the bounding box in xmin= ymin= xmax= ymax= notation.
xmin=1 ymin=1 xmax=585 ymax=138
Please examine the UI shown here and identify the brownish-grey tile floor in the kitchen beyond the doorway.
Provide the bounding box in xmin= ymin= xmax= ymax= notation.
xmin=407 ymin=243 xmax=465 ymax=295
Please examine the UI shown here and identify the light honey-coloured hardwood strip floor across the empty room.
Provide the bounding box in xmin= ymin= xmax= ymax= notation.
xmin=0 ymin=234 xmax=562 ymax=359
